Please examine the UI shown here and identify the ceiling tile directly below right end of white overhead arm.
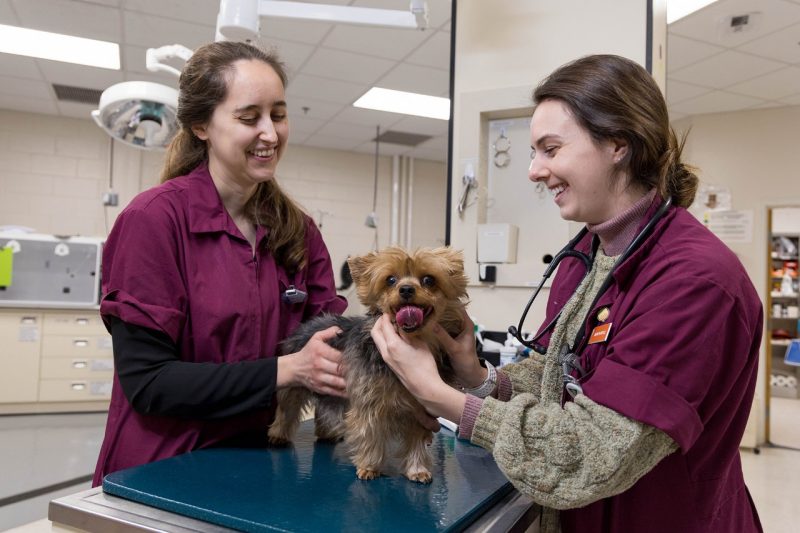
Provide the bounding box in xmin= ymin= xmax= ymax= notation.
xmin=322 ymin=24 xmax=428 ymax=60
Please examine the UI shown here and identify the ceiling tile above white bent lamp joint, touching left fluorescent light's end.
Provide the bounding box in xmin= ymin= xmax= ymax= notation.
xmin=122 ymin=11 xmax=216 ymax=50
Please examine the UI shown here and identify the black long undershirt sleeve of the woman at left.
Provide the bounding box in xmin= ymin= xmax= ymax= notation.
xmin=108 ymin=317 xmax=278 ymax=420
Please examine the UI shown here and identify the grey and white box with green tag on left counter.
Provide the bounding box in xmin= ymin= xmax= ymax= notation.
xmin=0 ymin=232 xmax=103 ymax=308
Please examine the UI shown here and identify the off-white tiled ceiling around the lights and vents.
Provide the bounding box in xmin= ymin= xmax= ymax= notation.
xmin=0 ymin=0 xmax=800 ymax=161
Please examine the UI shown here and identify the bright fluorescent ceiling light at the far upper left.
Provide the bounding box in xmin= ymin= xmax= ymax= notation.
xmin=0 ymin=24 xmax=119 ymax=70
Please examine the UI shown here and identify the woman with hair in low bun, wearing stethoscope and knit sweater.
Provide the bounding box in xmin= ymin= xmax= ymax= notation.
xmin=372 ymin=55 xmax=763 ymax=533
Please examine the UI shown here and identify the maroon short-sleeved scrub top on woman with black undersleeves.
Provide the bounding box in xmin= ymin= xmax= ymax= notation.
xmin=94 ymin=163 xmax=347 ymax=485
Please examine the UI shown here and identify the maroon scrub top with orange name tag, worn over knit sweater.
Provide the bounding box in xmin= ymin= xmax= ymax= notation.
xmin=544 ymin=196 xmax=763 ymax=533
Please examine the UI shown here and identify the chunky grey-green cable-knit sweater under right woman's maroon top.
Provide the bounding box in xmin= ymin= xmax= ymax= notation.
xmin=471 ymin=251 xmax=678 ymax=533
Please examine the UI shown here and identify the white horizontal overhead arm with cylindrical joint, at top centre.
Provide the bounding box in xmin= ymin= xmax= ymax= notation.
xmin=217 ymin=0 xmax=428 ymax=40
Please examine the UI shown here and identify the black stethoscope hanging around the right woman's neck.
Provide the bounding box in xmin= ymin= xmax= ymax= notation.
xmin=508 ymin=197 xmax=672 ymax=398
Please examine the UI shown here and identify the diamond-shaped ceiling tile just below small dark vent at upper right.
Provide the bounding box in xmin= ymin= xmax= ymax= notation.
xmin=670 ymin=50 xmax=784 ymax=89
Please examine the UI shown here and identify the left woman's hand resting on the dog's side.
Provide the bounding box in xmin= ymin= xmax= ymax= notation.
xmin=278 ymin=326 xmax=347 ymax=398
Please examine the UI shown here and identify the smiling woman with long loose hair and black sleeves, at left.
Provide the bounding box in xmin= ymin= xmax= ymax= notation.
xmin=94 ymin=42 xmax=346 ymax=485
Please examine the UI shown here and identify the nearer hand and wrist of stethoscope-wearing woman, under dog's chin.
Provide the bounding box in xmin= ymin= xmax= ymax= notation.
xmin=372 ymin=314 xmax=466 ymax=425
